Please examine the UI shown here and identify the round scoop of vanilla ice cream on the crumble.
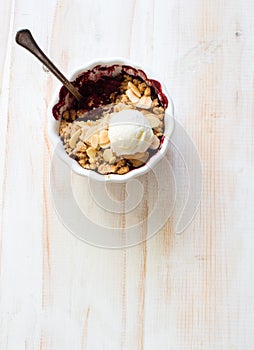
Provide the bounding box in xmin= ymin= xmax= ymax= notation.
xmin=108 ymin=109 xmax=154 ymax=156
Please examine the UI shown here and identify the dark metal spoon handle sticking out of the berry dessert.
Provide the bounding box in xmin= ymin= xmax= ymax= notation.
xmin=16 ymin=29 xmax=83 ymax=101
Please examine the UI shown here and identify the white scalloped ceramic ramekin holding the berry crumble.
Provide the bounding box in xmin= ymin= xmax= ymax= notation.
xmin=48 ymin=57 xmax=174 ymax=183
